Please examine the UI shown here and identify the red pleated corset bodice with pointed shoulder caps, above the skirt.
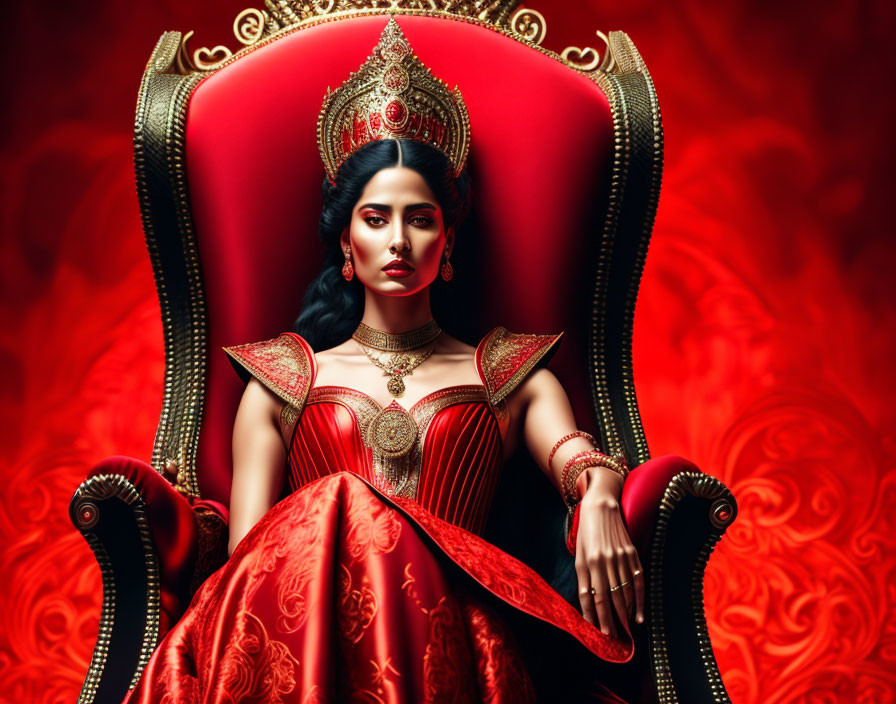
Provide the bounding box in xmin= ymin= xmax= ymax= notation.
xmin=225 ymin=327 xmax=560 ymax=534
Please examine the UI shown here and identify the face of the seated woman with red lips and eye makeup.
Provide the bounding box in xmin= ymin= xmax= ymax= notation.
xmin=342 ymin=167 xmax=453 ymax=296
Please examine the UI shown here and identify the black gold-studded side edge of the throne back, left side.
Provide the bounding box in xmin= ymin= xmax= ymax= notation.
xmin=134 ymin=32 xmax=207 ymax=495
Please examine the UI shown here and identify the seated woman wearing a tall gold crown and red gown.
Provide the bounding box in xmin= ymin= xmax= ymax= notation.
xmin=128 ymin=19 xmax=644 ymax=702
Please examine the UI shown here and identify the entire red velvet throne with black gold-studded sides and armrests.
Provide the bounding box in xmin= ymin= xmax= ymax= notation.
xmin=70 ymin=0 xmax=736 ymax=703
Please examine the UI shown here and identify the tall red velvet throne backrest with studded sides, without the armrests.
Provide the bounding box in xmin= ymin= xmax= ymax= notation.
xmin=136 ymin=2 xmax=662 ymax=503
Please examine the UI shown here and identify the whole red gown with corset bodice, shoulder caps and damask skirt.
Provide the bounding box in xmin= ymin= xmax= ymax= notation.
xmin=130 ymin=327 xmax=633 ymax=704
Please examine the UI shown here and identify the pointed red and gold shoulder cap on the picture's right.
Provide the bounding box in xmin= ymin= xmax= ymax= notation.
xmin=476 ymin=327 xmax=563 ymax=405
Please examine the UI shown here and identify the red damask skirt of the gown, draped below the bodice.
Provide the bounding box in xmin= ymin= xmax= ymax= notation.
xmin=128 ymin=472 xmax=632 ymax=704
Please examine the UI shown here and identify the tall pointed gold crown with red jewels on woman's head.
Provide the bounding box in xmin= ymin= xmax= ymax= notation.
xmin=317 ymin=16 xmax=470 ymax=184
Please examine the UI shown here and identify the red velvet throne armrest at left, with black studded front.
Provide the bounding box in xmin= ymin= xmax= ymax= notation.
xmin=69 ymin=456 xmax=227 ymax=702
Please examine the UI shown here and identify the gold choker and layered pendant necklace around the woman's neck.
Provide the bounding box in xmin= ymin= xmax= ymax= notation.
xmin=352 ymin=320 xmax=442 ymax=398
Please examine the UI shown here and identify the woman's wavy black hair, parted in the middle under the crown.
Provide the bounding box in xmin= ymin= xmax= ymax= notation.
xmin=292 ymin=139 xmax=474 ymax=351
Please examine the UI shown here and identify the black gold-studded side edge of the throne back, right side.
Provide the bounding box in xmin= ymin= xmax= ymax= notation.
xmin=589 ymin=32 xmax=663 ymax=467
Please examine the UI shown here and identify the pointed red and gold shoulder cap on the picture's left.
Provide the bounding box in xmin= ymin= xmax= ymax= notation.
xmin=223 ymin=332 xmax=316 ymax=410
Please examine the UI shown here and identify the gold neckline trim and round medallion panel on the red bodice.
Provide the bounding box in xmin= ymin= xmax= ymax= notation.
xmin=306 ymin=385 xmax=494 ymax=499
